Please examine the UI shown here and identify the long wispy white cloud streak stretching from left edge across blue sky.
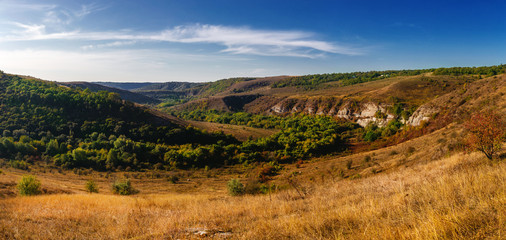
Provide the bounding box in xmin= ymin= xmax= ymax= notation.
xmin=0 ymin=23 xmax=364 ymax=58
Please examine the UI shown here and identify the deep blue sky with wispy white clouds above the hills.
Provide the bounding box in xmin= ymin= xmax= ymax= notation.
xmin=0 ymin=0 xmax=506 ymax=82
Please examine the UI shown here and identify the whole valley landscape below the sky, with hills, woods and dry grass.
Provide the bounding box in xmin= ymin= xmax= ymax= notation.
xmin=0 ymin=65 xmax=506 ymax=239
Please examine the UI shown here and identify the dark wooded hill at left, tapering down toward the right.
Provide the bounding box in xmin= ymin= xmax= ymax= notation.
xmin=0 ymin=72 xmax=237 ymax=170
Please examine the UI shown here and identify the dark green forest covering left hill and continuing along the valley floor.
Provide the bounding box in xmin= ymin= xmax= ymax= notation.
xmin=0 ymin=70 xmax=356 ymax=170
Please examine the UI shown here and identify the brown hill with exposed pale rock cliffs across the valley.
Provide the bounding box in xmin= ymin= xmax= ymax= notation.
xmin=173 ymin=65 xmax=506 ymax=127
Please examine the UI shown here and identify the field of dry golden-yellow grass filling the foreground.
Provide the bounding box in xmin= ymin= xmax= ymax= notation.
xmin=0 ymin=153 xmax=506 ymax=239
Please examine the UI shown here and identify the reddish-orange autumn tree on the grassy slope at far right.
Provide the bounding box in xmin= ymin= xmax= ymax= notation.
xmin=465 ymin=111 xmax=506 ymax=159
